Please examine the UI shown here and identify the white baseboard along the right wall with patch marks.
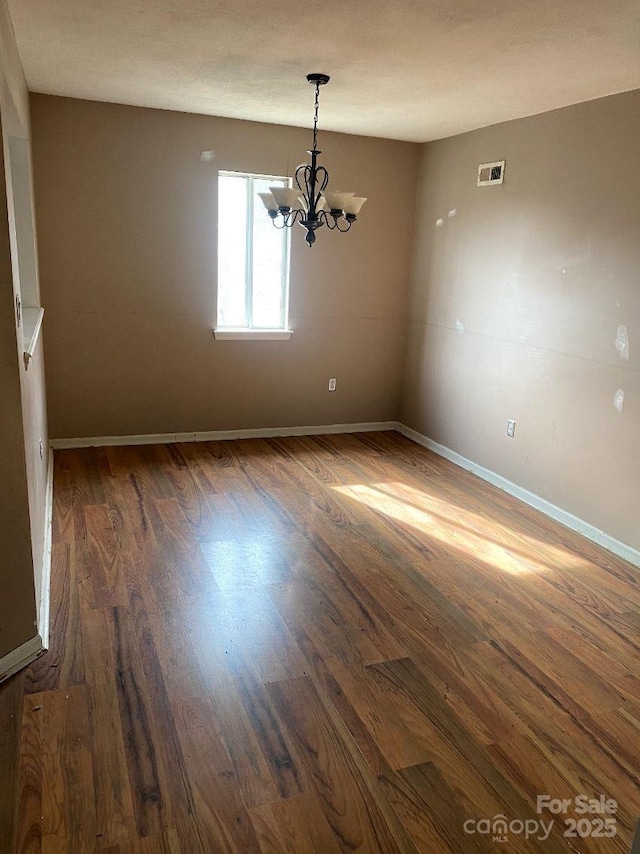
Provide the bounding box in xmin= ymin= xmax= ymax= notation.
xmin=396 ymin=424 xmax=640 ymax=567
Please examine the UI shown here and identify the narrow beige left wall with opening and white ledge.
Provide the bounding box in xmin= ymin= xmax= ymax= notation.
xmin=0 ymin=2 xmax=48 ymax=658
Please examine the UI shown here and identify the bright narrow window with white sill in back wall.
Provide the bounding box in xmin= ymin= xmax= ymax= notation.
xmin=215 ymin=172 xmax=291 ymax=338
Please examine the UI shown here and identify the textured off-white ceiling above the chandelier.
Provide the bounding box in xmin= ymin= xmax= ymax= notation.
xmin=8 ymin=0 xmax=640 ymax=142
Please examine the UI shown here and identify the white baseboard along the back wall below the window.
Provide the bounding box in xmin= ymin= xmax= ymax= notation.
xmin=50 ymin=421 xmax=398 ymax=450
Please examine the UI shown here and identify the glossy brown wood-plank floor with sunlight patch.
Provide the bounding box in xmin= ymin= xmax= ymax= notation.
xmin=5 ymin=433 xmax=640 ymax=854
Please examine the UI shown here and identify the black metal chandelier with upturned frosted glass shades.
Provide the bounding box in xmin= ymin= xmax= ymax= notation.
xmin=258 ymin=74 xmax=367 ymax=246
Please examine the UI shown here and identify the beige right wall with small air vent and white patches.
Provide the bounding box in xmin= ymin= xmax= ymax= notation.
xmin=401 ymin=91 xmax=640 ymax=548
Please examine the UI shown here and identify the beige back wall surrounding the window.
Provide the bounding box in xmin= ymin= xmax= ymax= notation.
xmin=31 ymin=95 xmax=419 ymax=438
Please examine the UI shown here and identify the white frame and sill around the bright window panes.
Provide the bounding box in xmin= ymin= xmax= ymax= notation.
xmin=213 ymin=169 xmax=293 ymax=341
